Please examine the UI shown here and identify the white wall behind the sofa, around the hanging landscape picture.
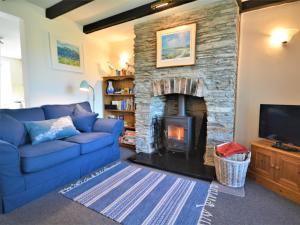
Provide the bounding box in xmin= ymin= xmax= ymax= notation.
xmin=0 ymin=0 xmax=110 ymax=115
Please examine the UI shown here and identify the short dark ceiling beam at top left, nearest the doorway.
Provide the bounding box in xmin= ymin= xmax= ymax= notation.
xmin=46 ymin=0 xmax=94 ymax=19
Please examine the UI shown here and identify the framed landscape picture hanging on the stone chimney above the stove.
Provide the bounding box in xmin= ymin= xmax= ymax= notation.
xmin=156 ymin=23 xmax=196 ymax=68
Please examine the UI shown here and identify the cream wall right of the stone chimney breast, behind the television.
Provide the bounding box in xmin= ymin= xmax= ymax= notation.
xmin=235 ymin=2 xmax=300 ymax=146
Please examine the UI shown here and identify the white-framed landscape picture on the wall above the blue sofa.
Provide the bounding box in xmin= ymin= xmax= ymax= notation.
xmin=50 ymin=35 xmax=84 ymax=73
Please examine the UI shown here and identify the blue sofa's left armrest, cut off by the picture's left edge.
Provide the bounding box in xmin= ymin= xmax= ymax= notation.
xmin=0 ymin=140 xmax=25 ymax=195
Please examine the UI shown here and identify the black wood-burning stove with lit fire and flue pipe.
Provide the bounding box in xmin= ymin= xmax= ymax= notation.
xmin=163 ymin=95 xmax=194 ymax=159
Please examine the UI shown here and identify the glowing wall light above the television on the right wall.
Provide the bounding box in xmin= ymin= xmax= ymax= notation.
xmin=271 ymin=28 xmax=299 ymax=47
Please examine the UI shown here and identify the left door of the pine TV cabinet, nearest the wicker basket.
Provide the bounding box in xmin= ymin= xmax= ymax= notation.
xmin=251 ymin=146 xmax=275 ymax=179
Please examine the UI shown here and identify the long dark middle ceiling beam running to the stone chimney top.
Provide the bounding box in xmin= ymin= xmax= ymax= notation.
xmin=83 ymin=0 xmax=196 ymax=34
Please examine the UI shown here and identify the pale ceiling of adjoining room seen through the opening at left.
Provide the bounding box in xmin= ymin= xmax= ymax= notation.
xmin=0 ymin=12 xmax=21 ymax=59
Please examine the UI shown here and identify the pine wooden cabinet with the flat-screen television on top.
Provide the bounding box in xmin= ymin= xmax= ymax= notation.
xmin=249 ymin=140 xmax=300 ymax=204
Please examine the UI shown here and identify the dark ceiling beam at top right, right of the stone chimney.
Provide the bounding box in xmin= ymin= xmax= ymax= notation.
xmin=241 ymin=0 xmax=299 ymax=13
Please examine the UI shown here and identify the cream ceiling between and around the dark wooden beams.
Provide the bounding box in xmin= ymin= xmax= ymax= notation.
xmin=27 ymin=0 xmax=227 ymax=42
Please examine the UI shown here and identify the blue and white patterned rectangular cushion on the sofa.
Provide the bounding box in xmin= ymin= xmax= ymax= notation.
xmin=25 ymin=116 xmax=80 ymax=145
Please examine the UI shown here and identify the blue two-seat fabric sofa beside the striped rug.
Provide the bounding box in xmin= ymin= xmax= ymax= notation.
xmin=0 ymin=102 xmax=123 ymax=213
